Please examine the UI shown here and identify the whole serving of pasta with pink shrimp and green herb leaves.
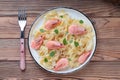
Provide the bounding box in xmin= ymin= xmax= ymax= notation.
xmin=31 ymin=10 xmax=95 ymax=71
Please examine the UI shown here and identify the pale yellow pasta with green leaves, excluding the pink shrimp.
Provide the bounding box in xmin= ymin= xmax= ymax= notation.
xmin=31 ymin=10 xmax=94 ymax=70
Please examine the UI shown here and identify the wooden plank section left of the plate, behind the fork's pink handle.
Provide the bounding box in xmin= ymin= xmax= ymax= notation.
xmin=0 ymin=39 xmax=32 ymax=60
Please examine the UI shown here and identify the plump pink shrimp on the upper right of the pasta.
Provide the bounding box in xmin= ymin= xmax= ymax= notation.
xmin=69 ymin=24 xmax=86 ymax=35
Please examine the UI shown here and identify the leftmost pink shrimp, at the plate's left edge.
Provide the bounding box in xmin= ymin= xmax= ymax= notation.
xmin=31 ymin=36 xmax=44 ymax=49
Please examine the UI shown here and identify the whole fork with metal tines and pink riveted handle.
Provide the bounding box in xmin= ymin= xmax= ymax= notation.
xmin=18 ymin=9 xmax=27 ymax=71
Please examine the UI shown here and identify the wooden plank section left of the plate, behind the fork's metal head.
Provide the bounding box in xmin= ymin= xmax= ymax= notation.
xmin=0 ymin=17 xmax=35 ymax=38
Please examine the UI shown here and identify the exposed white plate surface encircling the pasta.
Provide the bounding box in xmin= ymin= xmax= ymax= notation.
xmin=28 ymin=7 xmax=96 ymax=73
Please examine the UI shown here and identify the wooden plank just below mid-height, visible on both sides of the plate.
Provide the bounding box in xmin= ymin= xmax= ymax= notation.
xmin=0 ymin=39 xmax=120 ymax=61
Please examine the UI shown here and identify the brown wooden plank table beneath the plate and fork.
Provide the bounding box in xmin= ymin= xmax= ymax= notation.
xmin=0 ymin=0 xmax=120 ymax=80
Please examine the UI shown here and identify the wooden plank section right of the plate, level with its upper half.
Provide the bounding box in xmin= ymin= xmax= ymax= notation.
xmin=92 ymin=18 xmax=120 ymax=39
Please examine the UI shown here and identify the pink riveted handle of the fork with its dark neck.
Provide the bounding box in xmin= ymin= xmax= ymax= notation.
xmin=20 ymin=32 xmax=25 ymax=71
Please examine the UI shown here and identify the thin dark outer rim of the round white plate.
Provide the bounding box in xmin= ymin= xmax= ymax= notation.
xmin=27 ymin=6 xmax=97 ymax=74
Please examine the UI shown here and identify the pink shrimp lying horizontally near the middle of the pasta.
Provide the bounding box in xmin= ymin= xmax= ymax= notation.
xmin=46 ymin=41 xmax=64 ymax=49
